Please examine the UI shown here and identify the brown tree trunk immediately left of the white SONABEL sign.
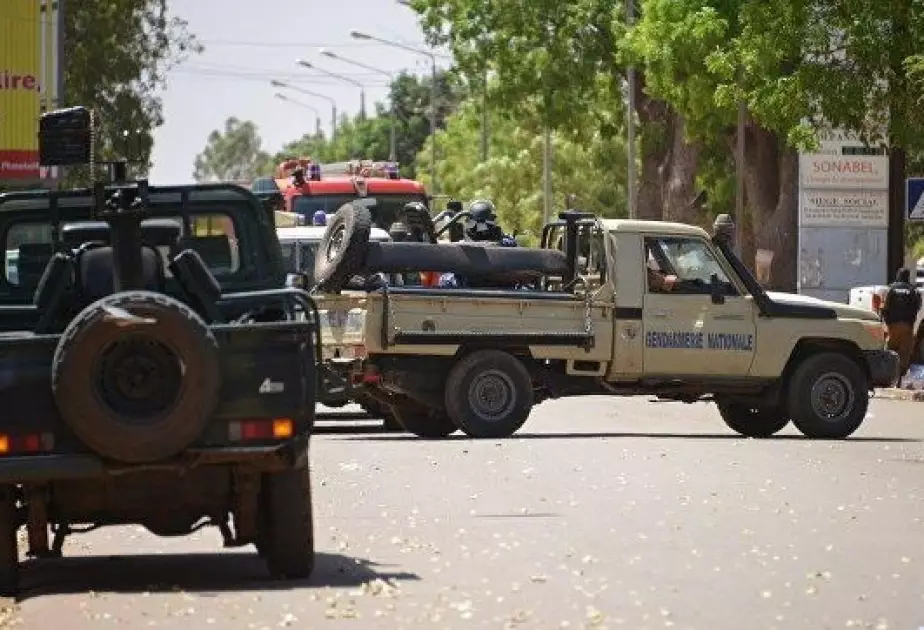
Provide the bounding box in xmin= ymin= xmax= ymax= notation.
xmin=745 ymin=122 xmax=799 ymax=291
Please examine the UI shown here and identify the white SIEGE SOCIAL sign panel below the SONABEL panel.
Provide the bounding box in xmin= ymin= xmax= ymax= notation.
xmin=799 ymin=190 xmax=889 ymax=228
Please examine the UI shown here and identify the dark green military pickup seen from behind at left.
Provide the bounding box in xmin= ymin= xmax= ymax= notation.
xmin=0 ymin=108 xmax=320 ymax=595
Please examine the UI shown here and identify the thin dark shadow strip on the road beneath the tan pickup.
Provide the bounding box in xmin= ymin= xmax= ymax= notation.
xmin=336 ymin=431 xmax=924 ymax=444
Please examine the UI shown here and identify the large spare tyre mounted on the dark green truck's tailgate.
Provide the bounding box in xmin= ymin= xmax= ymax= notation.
xmin=51 ymin=291 xmax=221 ymax=464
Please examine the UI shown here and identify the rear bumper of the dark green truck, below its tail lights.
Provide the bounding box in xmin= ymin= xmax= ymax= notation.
xmin=0 ymin=436 xmax=309 ymax=484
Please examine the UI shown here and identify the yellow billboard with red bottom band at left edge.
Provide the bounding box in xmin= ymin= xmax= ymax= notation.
xmin=0 ymin=0 xmax=60 ymax=182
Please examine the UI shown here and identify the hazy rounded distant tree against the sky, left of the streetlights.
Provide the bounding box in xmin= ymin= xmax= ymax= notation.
xmin=193 ymin=116 xmax=271 ymax=182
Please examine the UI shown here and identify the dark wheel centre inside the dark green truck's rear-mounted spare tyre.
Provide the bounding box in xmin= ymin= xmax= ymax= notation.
xmin=95 ymin=335 xmax=184 ymax=424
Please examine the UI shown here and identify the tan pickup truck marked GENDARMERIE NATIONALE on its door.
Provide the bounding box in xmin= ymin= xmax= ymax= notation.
xmin=315 ymin=206 xmax=898 ymax=438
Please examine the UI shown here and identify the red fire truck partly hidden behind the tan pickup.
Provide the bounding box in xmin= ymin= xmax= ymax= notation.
xmin=251 ymin=157 xmax=430 ymax=230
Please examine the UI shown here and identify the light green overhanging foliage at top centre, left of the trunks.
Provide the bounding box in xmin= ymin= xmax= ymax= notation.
xmin=411 ymin=0 xmax=621 ymax=133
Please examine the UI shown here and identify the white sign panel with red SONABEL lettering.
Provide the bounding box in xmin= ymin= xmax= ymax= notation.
xmin=799 ymin=153 xmax=889 ymax=190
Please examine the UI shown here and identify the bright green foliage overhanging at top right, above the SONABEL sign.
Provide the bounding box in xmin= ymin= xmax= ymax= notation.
xmin=622 ymin=0 xmax=924 ymax=153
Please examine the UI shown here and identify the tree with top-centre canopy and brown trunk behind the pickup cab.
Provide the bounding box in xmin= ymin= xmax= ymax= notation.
xmin=413 ymin=0 xmax=699 ymax=220
